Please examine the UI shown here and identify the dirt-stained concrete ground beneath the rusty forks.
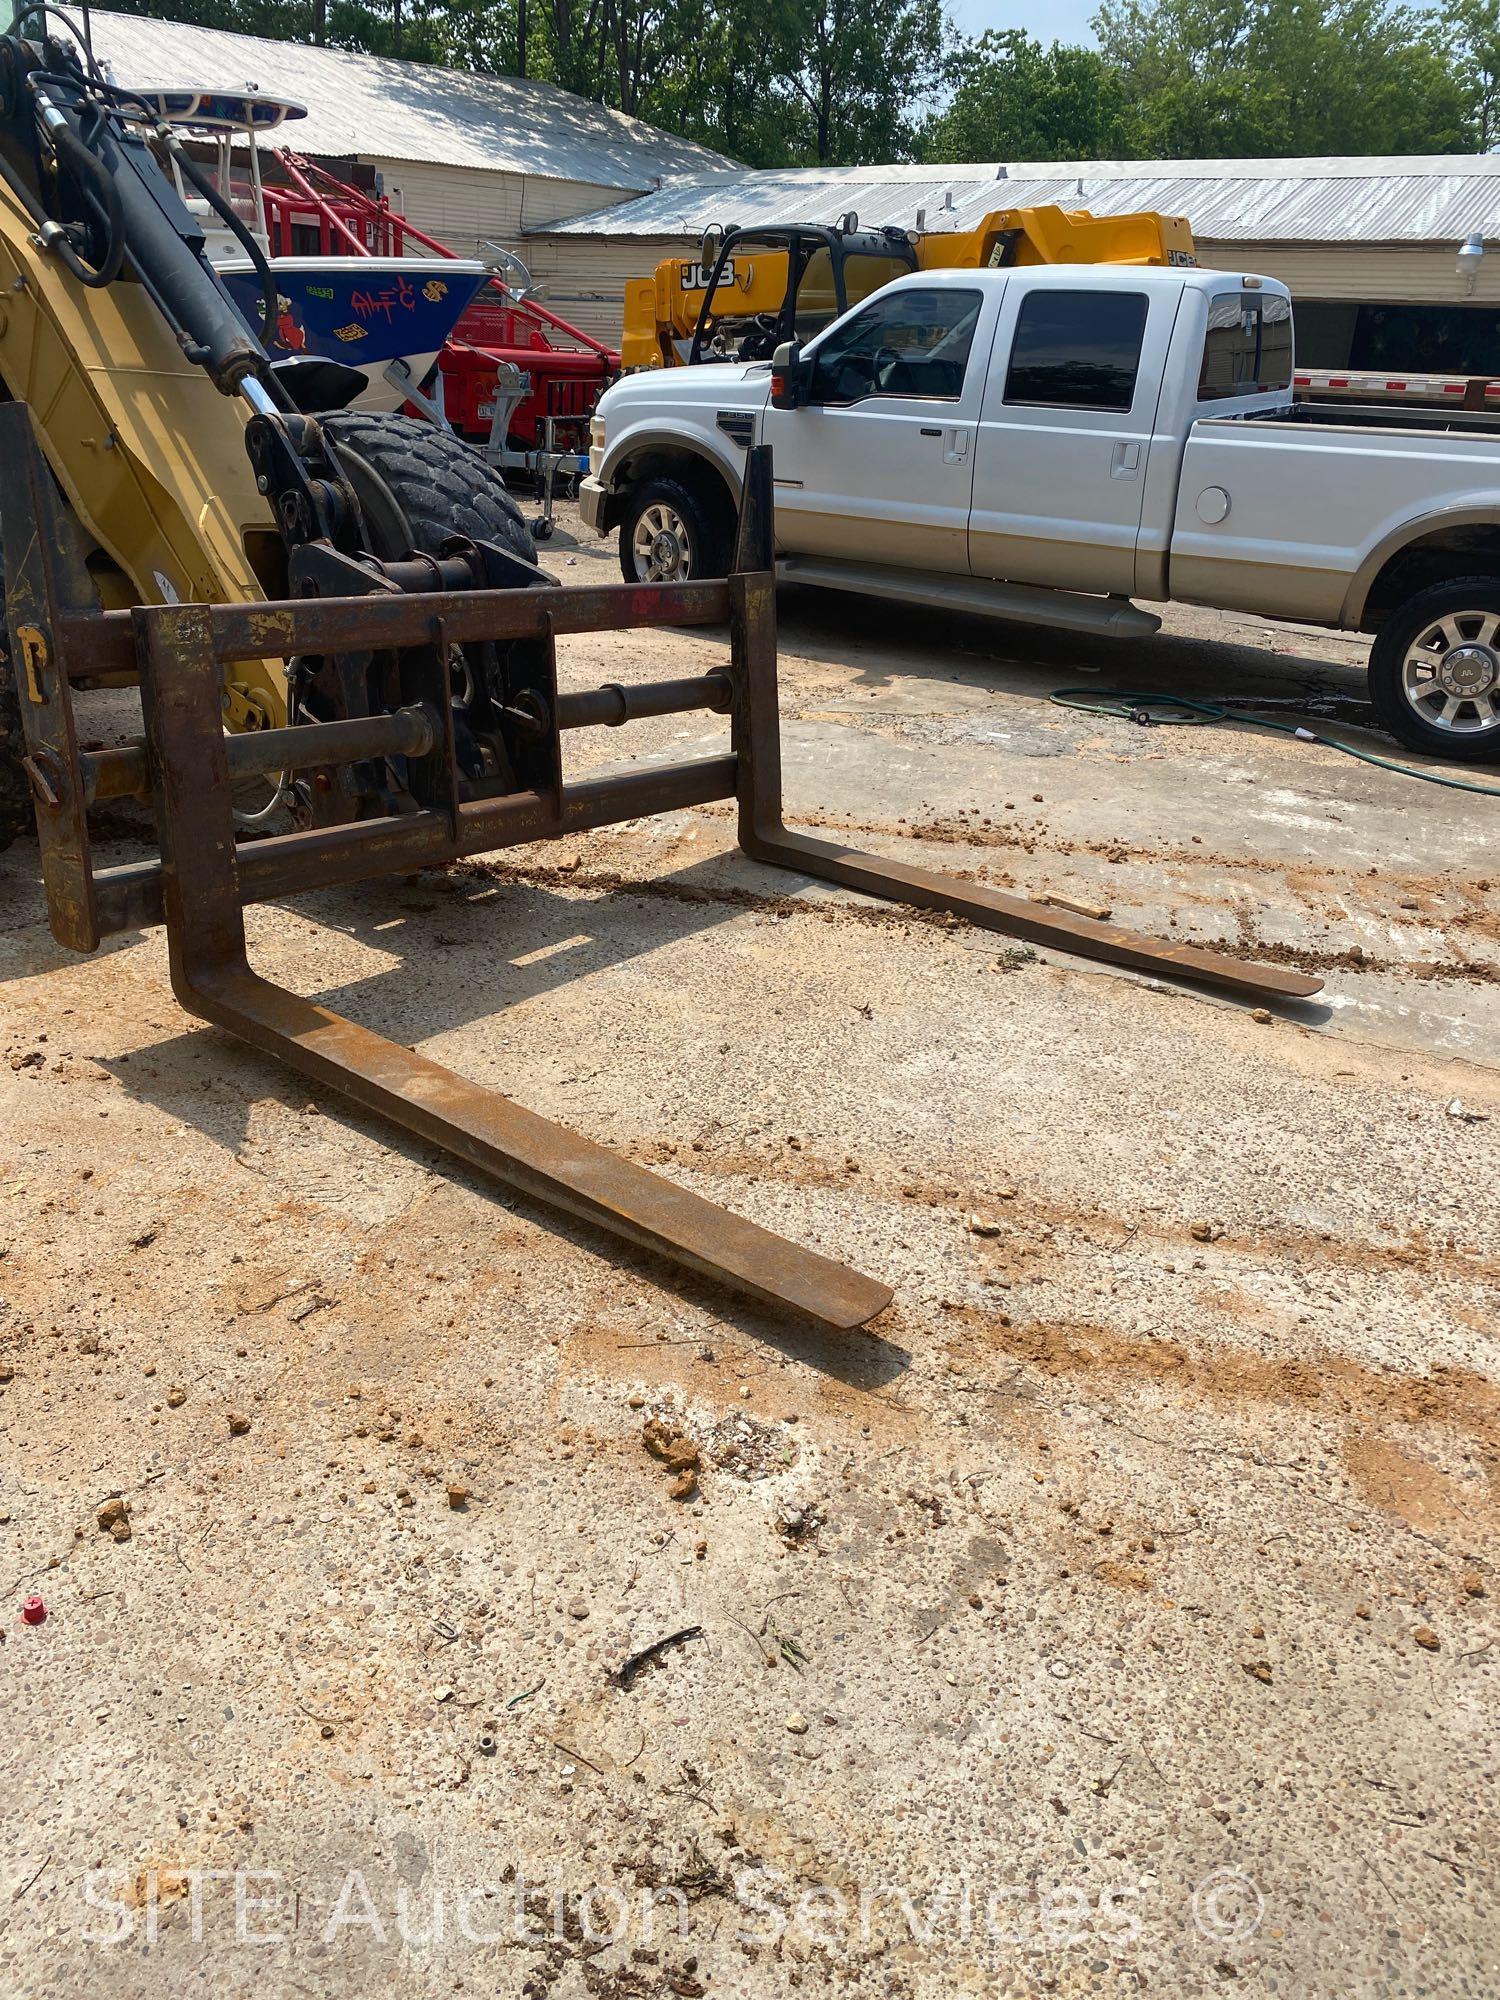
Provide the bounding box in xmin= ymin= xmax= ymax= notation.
xmin=0 ymin=504 xmax=1500 ymax=2000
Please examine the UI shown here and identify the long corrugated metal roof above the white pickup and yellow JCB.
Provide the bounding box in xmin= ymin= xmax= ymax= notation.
xmin=538 ymin=154 xmax=1500 ymax=242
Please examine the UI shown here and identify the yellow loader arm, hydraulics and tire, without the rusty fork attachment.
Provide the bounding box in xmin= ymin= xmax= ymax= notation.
xmin=0 ymin=6 xmax=542 ymax=844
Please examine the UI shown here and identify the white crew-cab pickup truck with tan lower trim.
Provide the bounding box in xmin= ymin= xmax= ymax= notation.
xmin=580 ymin=264 xmax=1500 ymax=762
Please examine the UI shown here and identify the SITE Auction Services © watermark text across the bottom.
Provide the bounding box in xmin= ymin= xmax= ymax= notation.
xmin=82 ymin=1866 xmax=1266 ymax=1952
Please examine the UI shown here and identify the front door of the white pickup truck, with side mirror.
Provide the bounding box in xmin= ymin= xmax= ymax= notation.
xmin=762 ymin=274 xmax=1004 ymax=576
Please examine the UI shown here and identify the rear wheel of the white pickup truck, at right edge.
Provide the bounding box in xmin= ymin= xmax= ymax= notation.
xmin=1370 ymin=576 xmax=1500 ymax=764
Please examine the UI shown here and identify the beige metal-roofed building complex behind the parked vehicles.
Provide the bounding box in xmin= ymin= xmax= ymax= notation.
xmin=67 ymin=12 xmax=1500 ymax=376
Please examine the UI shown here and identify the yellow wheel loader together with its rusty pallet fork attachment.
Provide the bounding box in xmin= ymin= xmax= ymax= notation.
xmin=0 ymin=19 xmax=1318 ymax=1330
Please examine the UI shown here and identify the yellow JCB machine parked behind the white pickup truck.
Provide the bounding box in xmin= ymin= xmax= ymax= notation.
xmin=620 ymin=206 xmax=1198 ymax=370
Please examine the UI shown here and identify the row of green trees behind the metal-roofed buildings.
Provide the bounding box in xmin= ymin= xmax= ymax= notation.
xmin=114 ymin=0 xmax=1500 ymax=166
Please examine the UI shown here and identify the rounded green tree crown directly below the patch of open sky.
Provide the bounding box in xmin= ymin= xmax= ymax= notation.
xmin=922 ymin=28 xmax=1128 ymax=160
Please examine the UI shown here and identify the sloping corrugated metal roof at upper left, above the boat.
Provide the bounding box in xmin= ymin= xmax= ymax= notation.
xmin=92 ymin=12 xmax=730 ymax=188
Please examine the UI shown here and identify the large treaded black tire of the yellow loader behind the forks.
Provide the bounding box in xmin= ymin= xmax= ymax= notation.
xmin=322 ymin=410 xmax=536 ymax=562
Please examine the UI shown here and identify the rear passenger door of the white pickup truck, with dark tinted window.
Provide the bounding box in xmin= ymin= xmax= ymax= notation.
xmin=968 ymin=270 xmax=1182 ymax=596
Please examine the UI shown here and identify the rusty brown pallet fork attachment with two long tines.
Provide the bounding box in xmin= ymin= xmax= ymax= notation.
xmin=0 ymin=424 xmax=1320 ymax=1328
